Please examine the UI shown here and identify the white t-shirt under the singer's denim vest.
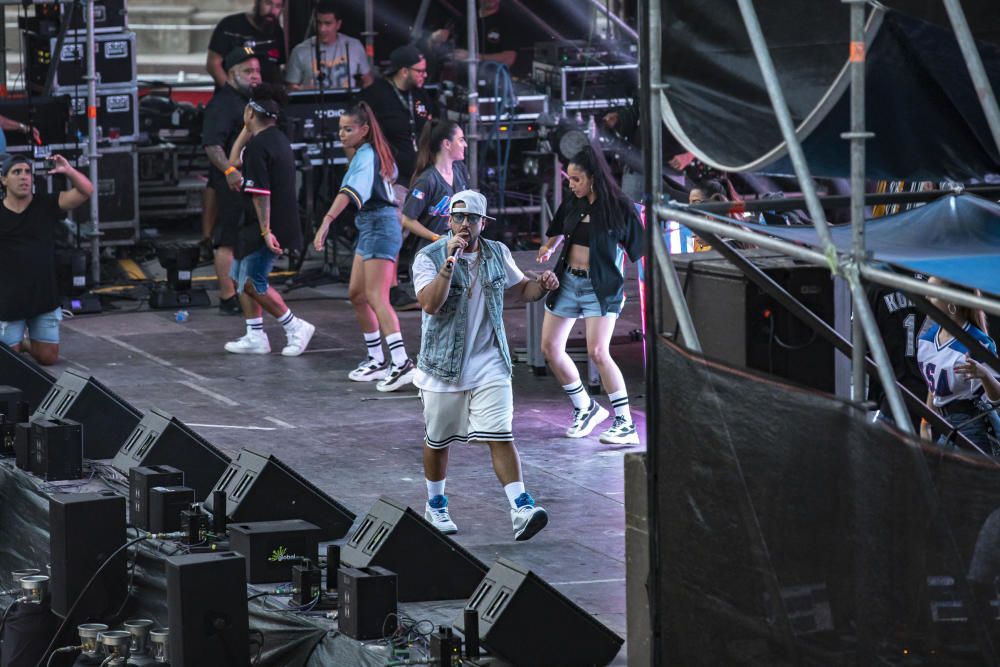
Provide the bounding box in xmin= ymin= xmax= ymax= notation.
xmin=413 ymin=245 xmax=524 ymax=392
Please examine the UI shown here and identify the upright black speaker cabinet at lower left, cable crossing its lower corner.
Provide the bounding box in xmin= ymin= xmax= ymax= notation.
xmin=49 ymin=492 xmax=127 ymax=621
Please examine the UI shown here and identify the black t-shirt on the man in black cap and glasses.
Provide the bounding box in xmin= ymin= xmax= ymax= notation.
xmin=358 ymin=79 xmax=437 ymax=185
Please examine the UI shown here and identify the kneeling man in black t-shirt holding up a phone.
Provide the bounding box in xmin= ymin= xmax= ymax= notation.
xmin=0 ymin=155 xmax=94 ymax=365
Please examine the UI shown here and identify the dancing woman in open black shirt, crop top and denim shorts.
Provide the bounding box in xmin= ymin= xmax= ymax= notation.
xmin=538 ymin=147 xmax=645 ymax=444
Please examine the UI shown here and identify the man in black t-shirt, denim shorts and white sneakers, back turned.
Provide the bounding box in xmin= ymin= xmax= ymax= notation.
xmin=226 ymin=83 xmax=316 ymax=357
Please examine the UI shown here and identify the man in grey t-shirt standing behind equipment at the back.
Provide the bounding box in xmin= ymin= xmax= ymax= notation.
xmin=285 ymin=0 xmax=374 ymax=90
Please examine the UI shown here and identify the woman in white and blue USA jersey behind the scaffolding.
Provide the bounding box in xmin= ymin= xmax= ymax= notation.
xmin=917 ymin=278 xmax=1000 ymax=454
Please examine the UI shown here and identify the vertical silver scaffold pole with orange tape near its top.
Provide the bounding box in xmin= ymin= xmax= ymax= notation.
xmin=840 ymin=0 xmax=872 ymax=401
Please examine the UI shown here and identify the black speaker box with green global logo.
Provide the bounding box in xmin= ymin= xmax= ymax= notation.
xmin=229 ymin=519 xmax=321 ymax=584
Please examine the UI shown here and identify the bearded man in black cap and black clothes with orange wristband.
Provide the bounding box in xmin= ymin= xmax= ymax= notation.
xmin=201 ymin=47 xmax=260 ymax=315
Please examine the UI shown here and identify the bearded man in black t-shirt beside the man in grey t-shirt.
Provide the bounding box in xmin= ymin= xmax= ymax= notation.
xmin=205 ymin=0 xmax=285 ymax=88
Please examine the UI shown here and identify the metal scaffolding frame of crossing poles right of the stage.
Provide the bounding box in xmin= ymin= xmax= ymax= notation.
xmin=638 ymin=0 xmax=1000 ymax=664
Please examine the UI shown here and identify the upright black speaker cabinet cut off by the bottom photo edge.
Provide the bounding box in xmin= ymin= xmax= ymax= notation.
xmin=165 ymin=551 xmax=250 ymax=667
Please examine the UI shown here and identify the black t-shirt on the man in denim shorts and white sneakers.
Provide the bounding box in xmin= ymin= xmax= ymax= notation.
xmin=236 ymin=127 xmax=302 ymax=259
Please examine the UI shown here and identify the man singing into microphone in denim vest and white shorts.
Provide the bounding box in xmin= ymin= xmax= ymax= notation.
xmin=413 ymin=190 xmax=559 ymax=541
